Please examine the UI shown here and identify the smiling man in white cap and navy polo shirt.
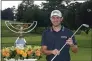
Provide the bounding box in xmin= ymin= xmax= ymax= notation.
xmin=41 ymin=10 xmax=78 ymax=61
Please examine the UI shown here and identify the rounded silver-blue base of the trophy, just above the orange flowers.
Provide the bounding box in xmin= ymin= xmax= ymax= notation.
xmin=15 ymin=36 xmax=26 ymax=49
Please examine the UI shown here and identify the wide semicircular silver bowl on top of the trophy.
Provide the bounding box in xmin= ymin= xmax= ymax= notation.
xmin=5 ymin=21 xmax=37 ymax=34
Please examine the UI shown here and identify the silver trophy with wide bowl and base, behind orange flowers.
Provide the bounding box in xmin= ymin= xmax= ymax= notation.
xmin=5 ymin=21 xmax=37 ymax=49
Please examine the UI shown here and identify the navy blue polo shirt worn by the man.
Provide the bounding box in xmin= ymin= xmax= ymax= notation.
xmin=41 ymin=26 xmax=77 ymax=61
